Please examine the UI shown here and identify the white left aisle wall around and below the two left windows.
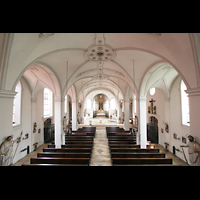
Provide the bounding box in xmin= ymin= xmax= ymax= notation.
xmin=12 ymin=78 xmax=54 ymax=163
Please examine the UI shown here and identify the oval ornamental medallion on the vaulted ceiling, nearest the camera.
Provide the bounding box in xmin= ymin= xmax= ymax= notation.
xmin=86 ymin=45 xmax=115 ymax=61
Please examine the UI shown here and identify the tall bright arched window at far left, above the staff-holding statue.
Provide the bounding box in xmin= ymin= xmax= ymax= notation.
xmin=13 ymin=81 xmax=22 ymax=126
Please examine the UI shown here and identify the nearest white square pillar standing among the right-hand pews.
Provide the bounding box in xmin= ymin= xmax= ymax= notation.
xmin=139 ymin=97 xmax=147 ymax=148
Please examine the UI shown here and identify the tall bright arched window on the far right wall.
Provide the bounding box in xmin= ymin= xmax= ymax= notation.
xmin=181 ymin=81 xmax=190 ymax=126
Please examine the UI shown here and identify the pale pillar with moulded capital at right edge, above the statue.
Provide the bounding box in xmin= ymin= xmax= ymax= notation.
xmin=186 ymin=88 xmax=200 ymax=143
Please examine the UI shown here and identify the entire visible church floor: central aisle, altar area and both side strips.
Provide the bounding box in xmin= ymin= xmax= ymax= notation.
xmin=15 ymin=117 xmax=187 ymax=166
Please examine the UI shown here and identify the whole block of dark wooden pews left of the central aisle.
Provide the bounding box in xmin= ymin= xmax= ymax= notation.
xmin=22 ymin=127 xmax=96 ymax=166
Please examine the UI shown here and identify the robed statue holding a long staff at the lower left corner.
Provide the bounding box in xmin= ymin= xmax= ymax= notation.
xmin=0 ymin=131 xmax=23 ymax=166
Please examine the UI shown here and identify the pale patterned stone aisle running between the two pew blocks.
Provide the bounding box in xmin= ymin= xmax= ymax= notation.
xmin=90 ymin=126 xmax=112 ymax=166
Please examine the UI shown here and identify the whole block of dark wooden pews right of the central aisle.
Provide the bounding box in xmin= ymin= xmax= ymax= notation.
xmin=106 ymin=127 xmax=180 ymax=166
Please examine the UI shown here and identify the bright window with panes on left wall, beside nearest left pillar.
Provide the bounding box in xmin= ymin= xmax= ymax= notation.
xmin=44 ymin=88 xmax=53 ymax=117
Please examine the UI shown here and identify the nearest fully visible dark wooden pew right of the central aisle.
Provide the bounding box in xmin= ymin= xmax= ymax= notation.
xmin=112 ymin=158 xmax=172 ymax=165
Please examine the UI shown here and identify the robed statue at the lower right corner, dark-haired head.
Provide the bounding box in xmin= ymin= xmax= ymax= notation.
xmin=180 ymin=135 xmax=200 ymax=166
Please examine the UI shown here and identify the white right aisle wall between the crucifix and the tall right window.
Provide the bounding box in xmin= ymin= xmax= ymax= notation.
xmin=147 ymin=77 xmax=190 ymax=161
